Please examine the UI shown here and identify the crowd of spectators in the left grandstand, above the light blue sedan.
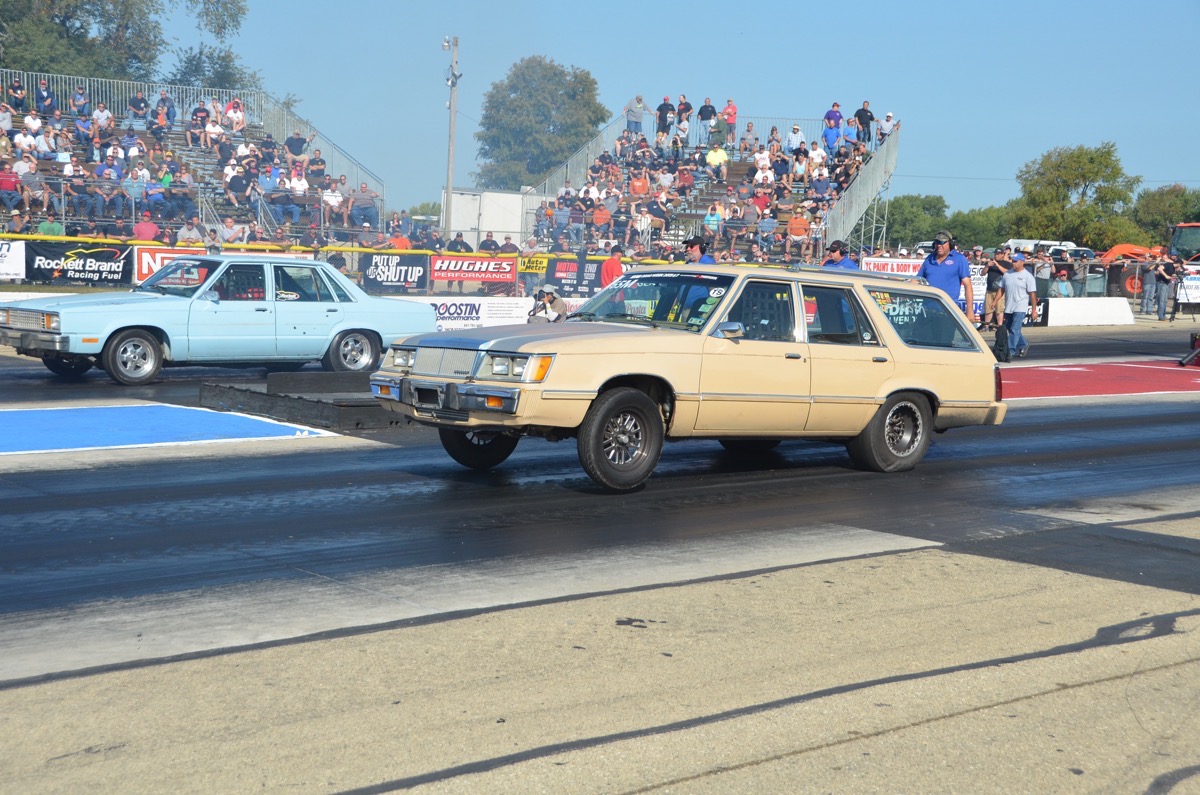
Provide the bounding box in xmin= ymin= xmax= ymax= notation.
xmin=0 ymin=77 xmax=380 ymax=243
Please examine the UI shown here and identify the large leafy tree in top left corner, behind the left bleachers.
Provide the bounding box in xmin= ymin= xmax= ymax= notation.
xmin=0 ymin=0 xmax=252 ymax=87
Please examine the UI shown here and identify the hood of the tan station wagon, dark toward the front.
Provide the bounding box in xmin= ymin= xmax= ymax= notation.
xmin=403 ymin=322 xmax=702 ymax=354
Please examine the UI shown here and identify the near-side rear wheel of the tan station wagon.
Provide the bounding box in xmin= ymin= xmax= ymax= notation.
xmin=846 ymin=393 xmax=934 ymax=472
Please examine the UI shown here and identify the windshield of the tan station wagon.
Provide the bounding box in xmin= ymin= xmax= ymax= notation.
xmin=566 ymin=273 xmax=733 ymax=331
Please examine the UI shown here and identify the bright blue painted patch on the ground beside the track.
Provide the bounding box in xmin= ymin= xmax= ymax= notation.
xmin=0 ymin=404 xmax=331 ymax=455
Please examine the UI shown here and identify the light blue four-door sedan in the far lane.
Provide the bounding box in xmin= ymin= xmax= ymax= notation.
xmin=0 ymin=256 xmax=436 ymax=385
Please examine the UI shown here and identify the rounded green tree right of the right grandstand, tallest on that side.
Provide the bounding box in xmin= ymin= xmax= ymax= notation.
xmin=1013 ymin=142 xmax=1141 ymax=249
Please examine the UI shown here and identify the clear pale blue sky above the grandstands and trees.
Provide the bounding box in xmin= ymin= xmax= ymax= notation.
xmin=164 ymin=0 xmax=1200 ymax=218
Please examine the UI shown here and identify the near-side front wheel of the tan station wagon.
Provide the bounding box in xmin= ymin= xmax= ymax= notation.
xmin=578 ymin=387 xmax=664 ymax=491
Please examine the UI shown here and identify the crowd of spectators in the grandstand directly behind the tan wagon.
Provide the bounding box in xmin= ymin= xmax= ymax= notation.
xmin=534 ymin=94 xmax=898 ymax=262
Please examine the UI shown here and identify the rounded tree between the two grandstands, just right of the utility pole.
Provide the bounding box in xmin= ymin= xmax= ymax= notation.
xmin=475 ymin=55 xmax=611 ymax=190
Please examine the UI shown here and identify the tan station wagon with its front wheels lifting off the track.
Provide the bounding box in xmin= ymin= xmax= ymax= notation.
xmin=371 ymin=265 xmax=1006 ymax=491
